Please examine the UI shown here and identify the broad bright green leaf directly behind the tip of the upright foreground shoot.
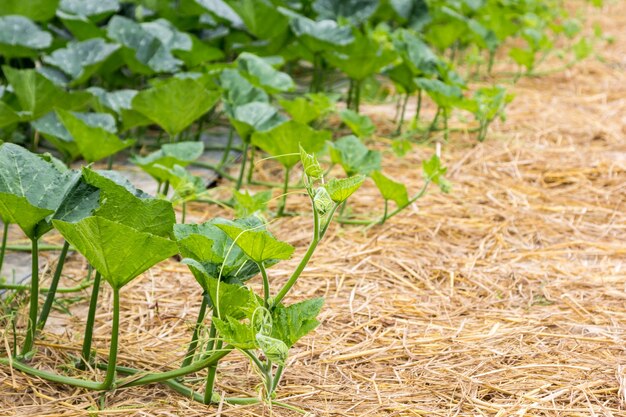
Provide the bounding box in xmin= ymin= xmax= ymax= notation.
xmin=252 ymin=120 xmax=332 ymax=169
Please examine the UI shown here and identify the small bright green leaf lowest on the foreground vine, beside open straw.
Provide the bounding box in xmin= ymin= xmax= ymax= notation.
xmin=272 ymin=298 xmax=324 ymax=347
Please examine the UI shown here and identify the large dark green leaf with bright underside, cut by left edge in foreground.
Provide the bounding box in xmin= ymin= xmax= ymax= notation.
xmin=0 ymin=143 xmax=72 ymax=239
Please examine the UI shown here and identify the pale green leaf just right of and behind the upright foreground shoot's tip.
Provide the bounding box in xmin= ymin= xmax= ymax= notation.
xmin=330 ymin=135 xmax=381 ymax=176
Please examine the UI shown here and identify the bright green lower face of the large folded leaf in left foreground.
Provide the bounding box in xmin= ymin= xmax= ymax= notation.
xmin=52 ymin=216 xmax=178 ymax=289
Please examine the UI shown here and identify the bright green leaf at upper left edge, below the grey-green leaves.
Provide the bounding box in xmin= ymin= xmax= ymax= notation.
xmin=2 ymin=66 xmax=91 ymax=120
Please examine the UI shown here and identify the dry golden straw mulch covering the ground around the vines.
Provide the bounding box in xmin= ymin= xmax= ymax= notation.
xmin=0 ymin=2 xmax=626 ymax=417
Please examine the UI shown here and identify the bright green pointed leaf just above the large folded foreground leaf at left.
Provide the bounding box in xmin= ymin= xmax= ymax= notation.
xmin=57 ymin=109 xmax=135 ymax=162
